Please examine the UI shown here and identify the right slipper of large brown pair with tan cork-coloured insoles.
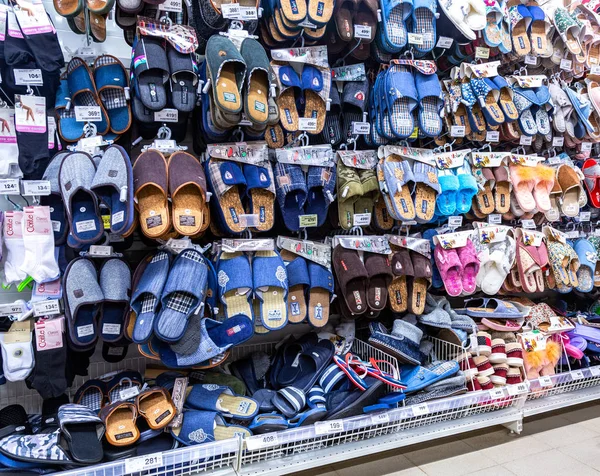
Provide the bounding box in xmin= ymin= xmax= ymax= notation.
xmin=167 ymin=152 xmax=207 ymax=236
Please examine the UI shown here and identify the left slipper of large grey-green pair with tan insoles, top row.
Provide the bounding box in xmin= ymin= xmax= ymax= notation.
xmin=206 ymin=35 xmax=245 ymax=114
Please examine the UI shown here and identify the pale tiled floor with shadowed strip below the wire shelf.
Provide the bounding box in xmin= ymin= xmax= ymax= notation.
xmin=296 ymin=403 xmax=600 ymax=476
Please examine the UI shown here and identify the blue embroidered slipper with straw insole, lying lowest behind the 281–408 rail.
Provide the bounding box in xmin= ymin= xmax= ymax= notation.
xmin=170 ymin=410 xmax=252 ymax=446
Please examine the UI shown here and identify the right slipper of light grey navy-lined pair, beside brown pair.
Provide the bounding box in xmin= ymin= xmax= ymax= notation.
xmin=91 ymin=145 xmax=134 ymax=235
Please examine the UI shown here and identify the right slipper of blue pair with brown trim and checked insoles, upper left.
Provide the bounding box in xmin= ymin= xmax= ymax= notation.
xmin=94 ymin=55 xmax=132 ymax=135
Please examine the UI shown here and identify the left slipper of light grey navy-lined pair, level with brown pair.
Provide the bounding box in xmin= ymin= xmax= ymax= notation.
xmin=58 ymin=152 xmax=104 ymax=244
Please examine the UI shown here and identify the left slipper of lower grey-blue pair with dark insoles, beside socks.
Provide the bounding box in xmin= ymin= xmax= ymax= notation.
xmin=63 ymin=258 xmax=104 ymax=349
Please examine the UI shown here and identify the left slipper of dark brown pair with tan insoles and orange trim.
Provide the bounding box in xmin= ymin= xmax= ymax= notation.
xmin=133 ymin=150 xmax=171 ymax=239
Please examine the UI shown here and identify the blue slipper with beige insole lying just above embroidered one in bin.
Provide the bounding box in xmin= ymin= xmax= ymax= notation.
xmin=185 ymin=383 xmax=258 ymax=420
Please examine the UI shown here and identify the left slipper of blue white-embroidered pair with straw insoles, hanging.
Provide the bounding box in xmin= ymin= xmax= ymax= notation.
xmin=217 ymin=253 xmax=253 ymax=320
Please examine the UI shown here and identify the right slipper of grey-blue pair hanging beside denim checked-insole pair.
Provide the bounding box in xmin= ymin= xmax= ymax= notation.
xmin=100 ymin=259 xmax=131 ymax=342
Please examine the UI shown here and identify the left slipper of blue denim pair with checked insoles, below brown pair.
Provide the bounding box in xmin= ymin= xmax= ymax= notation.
xmin=131 ymin=251 xmax=169 ymax=344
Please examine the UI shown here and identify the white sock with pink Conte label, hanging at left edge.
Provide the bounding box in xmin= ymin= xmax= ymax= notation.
xmin=21 ymin=207 xmax=60 ymax=283
